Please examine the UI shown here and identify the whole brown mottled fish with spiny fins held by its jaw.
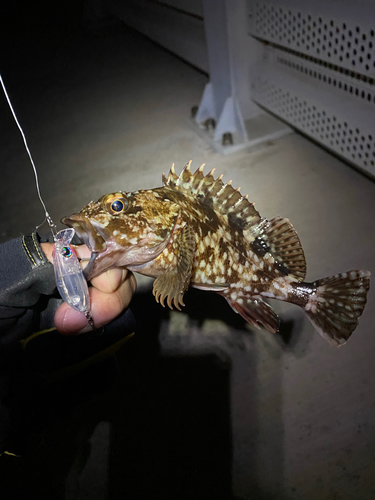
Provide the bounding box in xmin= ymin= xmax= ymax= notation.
xmin=61 ymin=161 xmax=370 ymax=346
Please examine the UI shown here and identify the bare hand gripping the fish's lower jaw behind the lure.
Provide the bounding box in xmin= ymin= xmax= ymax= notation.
xmin=40 ymin=243 xmax=137 ymax=335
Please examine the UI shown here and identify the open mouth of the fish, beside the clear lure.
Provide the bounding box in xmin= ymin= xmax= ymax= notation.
xmin=61 ymin=214 xmax=107 ymax=281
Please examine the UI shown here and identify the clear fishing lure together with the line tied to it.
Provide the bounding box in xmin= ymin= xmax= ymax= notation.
xmin=0 ymin=71 xmax=94 ymax=328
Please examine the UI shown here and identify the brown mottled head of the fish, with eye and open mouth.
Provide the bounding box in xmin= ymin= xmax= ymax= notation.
xmin=61 ymin=190 xmax=180 ymax=280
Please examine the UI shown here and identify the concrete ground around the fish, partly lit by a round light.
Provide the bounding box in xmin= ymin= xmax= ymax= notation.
xmin=0 ymin=17 xmax=375 ymax=500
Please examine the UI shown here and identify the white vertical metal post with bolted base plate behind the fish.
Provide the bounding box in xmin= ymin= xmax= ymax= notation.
xmin=195 ymin=0 xmax=290 ymax=150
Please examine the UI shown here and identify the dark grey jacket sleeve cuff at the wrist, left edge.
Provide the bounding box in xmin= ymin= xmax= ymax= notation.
xmin=0 ymin=232 xmax=56 ymax=342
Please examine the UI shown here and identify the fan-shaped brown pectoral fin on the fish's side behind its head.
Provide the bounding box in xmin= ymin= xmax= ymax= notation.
xmin=153 ymin=226 xmax=195 ymax=310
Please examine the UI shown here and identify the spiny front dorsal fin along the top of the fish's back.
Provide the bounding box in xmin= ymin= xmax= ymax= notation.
xmin=163 ymin=161 xmax=261 ymax=229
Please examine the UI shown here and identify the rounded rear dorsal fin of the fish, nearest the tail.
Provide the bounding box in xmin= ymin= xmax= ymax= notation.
xmin=251 ymin=217 xmax=306 ymax=281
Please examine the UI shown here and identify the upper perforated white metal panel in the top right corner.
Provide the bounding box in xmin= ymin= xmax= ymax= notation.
xmin=251 ymin=1 xmax=375 ymax=76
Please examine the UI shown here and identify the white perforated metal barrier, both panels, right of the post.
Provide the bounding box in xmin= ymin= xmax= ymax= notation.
xmin=249 ymin=0 xmax=375 ymax=176
